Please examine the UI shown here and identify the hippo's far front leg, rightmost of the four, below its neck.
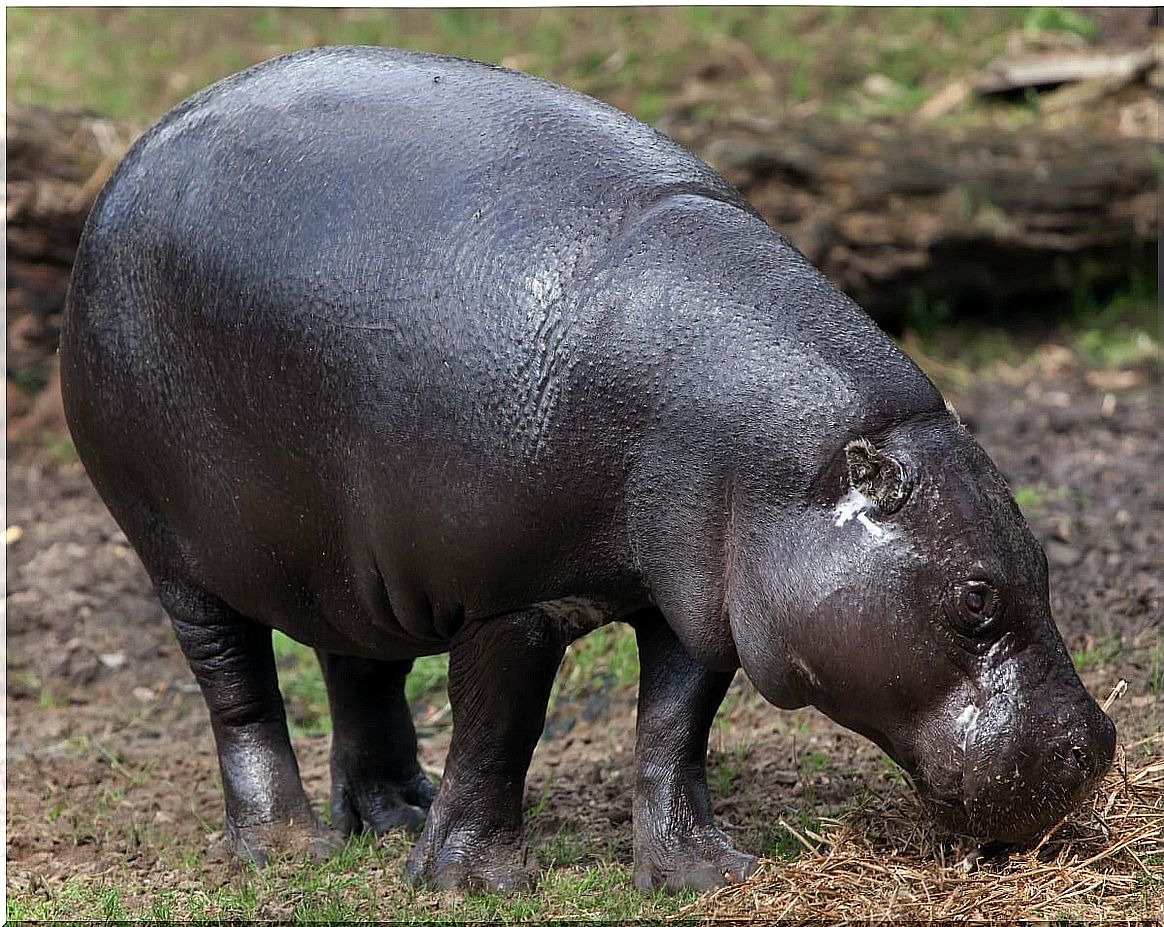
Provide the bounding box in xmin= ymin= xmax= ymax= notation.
xmin=633 ymin=613 xmax=758 ymax=891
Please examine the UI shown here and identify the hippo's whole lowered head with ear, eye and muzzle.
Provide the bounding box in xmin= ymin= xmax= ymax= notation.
xmin=729 ymin=415 xmax=1115 ymax=843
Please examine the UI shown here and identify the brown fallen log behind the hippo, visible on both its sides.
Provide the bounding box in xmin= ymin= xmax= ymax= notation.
xmin=7 ymin=101 xmax=1159 ymax=380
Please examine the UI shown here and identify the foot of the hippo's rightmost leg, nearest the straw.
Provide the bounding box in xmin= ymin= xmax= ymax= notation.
xmin=634 ymin=827 xmax=760 ymax=892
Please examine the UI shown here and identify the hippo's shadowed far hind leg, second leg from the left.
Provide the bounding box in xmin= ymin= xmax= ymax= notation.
xmin=318 ymin=651 xmax=437 ymax=834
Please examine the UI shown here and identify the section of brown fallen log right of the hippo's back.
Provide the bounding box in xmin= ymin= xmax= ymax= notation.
xmin=668 ymin=114 xmax=1161 ymax=331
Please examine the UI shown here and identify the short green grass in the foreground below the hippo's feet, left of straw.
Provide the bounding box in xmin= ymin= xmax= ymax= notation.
xmin=13 ymin=744 xmax=691 ymax=922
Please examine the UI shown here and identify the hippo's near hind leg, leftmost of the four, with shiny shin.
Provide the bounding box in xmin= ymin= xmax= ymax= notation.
xmin=155 ymin=578 xmax=340 ymax=866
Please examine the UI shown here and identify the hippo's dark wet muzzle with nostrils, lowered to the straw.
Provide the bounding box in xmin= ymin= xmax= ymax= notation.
xmin=954 ymin=692 xmax=1115 ymax=843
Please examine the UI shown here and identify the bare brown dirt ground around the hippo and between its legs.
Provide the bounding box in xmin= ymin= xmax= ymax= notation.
xmin=6 ymin=346 xmax=1164 ymax=917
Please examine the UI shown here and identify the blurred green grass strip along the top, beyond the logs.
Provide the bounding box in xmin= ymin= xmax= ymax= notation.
xmin=7 ymin=7 xmax=1096 ymax=128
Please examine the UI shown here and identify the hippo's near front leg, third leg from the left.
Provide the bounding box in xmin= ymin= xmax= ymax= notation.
xmin=405 ymin=610 xmax=567 ymax=894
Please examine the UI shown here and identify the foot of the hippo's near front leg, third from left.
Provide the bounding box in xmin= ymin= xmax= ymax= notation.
xmin=404 ymin=835 xmax=538 ymax=894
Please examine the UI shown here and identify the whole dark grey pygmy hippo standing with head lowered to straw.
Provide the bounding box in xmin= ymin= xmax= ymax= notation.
xmin=61 ymin=48 xmax=1114 ymax=891
